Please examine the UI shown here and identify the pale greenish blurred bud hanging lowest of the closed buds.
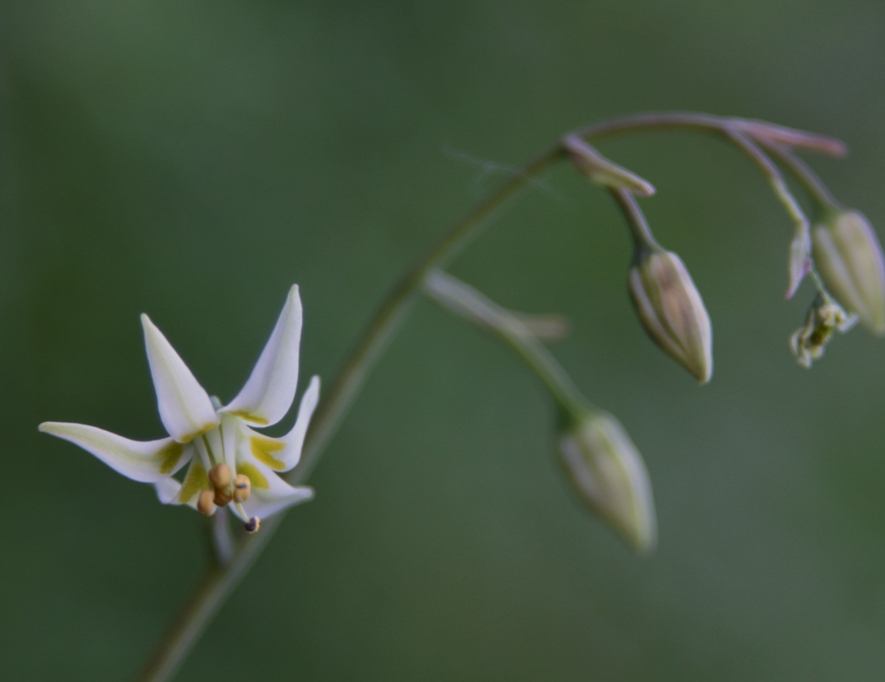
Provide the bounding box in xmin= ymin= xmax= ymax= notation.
xmin=558 ymin=411 xmax=657 ymax=552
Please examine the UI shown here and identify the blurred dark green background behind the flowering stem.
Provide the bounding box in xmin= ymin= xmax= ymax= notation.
xmin=0 ymin=0 xmax=885 ymax=682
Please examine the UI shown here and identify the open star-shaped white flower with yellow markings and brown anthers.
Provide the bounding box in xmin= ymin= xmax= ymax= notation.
xmin=40 ymin=285 xmax=320 ymax=532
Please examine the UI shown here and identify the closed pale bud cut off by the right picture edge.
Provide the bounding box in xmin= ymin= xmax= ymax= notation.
xmin=812 ymin=211 xmax=885 ymax=336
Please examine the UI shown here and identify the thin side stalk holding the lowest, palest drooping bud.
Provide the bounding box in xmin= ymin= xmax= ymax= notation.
xmin=424 ymin=270 xmax=587 ymax=413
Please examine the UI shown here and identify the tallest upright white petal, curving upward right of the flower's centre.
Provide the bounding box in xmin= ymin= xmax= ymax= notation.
xmin=222 ymin=284 xmax=301 ymax=426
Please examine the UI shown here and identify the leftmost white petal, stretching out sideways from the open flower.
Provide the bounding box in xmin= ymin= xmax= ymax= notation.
xmin=40 ymin=422 xmax=193 ymax=483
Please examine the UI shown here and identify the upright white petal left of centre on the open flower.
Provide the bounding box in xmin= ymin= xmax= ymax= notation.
xmin=141 ymin=315 xmax=218 ymax=443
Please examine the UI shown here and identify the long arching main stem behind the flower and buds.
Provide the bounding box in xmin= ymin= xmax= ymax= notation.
xmin=137 ymin=112 xmax=842 ymax=682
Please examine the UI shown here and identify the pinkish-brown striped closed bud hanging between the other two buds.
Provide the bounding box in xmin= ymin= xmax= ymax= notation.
xmin=629 ymin=246 xmax=713 ymax=384
